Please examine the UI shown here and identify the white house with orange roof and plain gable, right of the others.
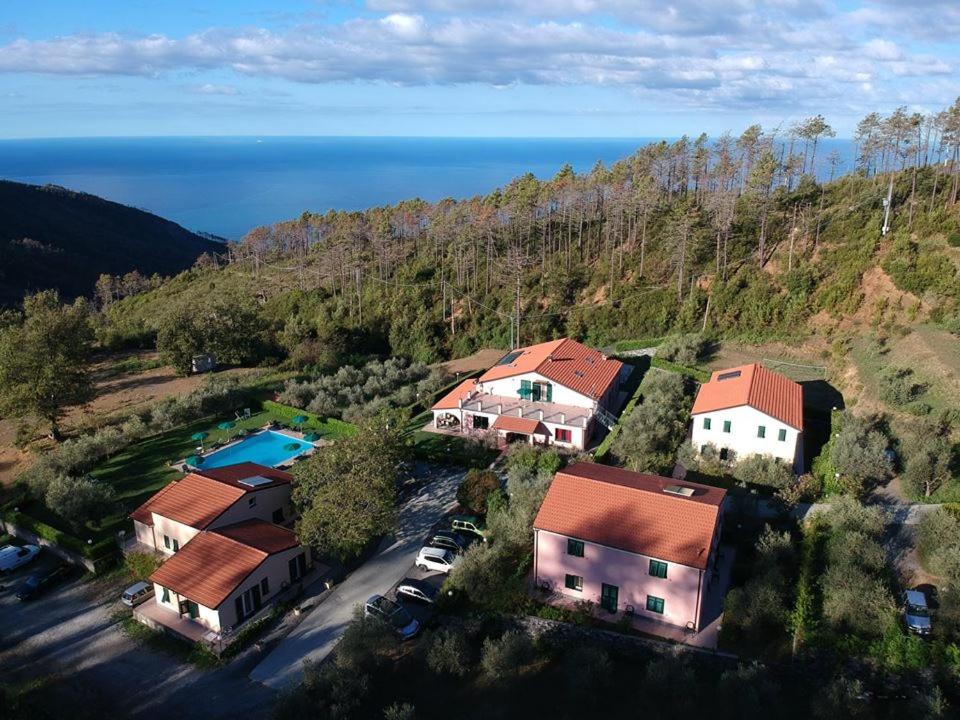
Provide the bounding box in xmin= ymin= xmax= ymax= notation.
xmin=691 ymin=363 xmax=803 ymax=474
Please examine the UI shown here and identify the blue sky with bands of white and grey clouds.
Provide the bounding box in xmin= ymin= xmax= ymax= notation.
xmin=0 ymin=0 xmax=960 ymax=138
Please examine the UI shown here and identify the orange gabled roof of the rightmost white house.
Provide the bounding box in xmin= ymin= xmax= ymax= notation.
xmin=692 ymin=363 xmax=803 ymax=431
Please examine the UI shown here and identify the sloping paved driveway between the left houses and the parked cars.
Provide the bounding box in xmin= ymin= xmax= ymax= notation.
xmin=250 ymin=466 xmax=466 ymax=690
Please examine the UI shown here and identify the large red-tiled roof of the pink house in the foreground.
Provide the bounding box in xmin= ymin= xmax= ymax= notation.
xmin=533 ymin=463 xmax=727 ymax=570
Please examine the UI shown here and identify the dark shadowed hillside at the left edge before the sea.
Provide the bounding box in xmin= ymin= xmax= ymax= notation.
xmin=0 ymin=181 xmax=221 ymax=306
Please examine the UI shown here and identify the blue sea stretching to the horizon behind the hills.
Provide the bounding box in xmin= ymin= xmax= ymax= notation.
xmin=0 ymin=137 xmax=856 ymax=240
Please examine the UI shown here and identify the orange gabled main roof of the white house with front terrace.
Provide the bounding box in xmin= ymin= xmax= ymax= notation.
xmin=480 ymin=338 xmax=623 ymax=398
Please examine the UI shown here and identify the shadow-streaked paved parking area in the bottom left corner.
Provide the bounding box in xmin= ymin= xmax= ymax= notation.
xmin=0 ymin=548 xmax=276 ymax=720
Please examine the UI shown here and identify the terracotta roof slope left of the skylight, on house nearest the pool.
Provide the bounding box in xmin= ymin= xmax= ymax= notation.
xmin=131 ymin=473 xmax=246 ymax=530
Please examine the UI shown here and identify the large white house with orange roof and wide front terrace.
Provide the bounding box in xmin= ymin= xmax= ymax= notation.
xmin=432 ymin=338 xmax=631 ymax=450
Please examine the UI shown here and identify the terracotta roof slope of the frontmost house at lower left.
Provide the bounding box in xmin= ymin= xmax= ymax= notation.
xmin=150 ymin=532 xmax=269 ymax=608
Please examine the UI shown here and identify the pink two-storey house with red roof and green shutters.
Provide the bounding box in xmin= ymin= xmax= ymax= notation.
xmin=533 ymin=463 xmax=726 ymax=631
